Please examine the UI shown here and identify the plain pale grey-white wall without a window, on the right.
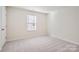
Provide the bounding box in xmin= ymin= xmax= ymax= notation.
xmin=48 ymin=7 xmax=79 ymax=44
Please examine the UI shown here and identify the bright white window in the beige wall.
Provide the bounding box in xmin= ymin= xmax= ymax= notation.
xmin=27 ymin=15 xmax=36 ymax=31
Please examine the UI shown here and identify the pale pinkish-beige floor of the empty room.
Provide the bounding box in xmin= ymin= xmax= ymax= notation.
xmin=2 ymin=36 xmax=79 ymax=52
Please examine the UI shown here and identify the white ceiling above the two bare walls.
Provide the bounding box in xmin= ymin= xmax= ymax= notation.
xmin=14 ymin=6 xmax=79 ymax=13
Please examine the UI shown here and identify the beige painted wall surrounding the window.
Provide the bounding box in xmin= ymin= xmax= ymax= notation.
xmin=7 ymin=7 xmax=47 ymax=41
